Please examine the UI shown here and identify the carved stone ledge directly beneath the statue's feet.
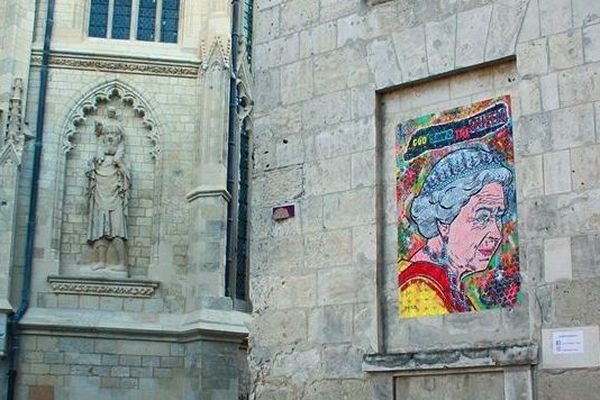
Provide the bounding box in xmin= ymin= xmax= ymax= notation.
xmin=48 ymin=276 xmax=159 ymax=298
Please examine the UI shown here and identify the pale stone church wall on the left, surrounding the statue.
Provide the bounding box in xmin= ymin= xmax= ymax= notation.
xmin=0 ymin=0 xmax=249 ymax=400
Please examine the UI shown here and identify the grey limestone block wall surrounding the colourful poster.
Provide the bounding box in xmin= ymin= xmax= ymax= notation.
xmin=250 ymin=0 xmax=600 ymax=400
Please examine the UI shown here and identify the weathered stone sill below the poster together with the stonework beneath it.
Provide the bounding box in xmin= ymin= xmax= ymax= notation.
xmin=363 ymin=343 xmax=538 ymax=400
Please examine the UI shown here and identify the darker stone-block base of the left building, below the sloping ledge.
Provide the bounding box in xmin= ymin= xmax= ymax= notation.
xmin=11 ymin=336 xmax=238 ymax=400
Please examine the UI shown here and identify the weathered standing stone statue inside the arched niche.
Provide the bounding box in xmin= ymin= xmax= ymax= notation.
xmin=85 ymin=107 xmax=131 ymax=277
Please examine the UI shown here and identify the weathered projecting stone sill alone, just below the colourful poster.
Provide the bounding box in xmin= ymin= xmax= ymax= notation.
xmin=362 ymin=342 xmax=538 ymax=372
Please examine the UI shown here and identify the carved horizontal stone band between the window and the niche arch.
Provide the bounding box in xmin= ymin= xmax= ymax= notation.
xmin=31 ymin=50 xmax=200 ymax=78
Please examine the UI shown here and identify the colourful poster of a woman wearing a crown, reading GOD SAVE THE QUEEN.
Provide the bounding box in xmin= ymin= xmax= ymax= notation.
xmin=396 ymin=96 xmax=521 ymax=318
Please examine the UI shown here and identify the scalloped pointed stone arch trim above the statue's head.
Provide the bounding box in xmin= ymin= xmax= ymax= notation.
xmin=61 ymin=80 xmax=161 ymax=159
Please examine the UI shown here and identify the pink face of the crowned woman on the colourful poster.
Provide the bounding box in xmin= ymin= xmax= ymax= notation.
xmin=442 ymin=182 xmax=506 ymax=275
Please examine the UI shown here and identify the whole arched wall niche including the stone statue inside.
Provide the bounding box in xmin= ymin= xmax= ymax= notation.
xmin=57 ymin=83 xmax=162 ymax=278
